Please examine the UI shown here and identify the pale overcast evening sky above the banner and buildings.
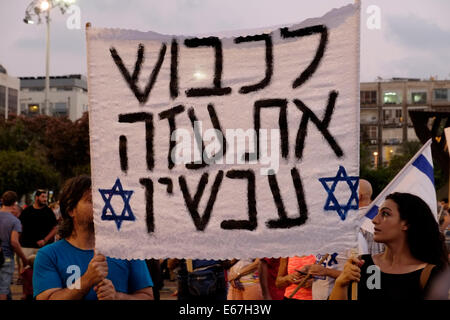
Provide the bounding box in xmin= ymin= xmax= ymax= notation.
xmin=0 ymin=0 xmax=450 ymax=81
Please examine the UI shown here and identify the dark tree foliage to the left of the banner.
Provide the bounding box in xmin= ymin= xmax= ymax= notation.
xmin=0 ymin=113 xmax=90 ymax=195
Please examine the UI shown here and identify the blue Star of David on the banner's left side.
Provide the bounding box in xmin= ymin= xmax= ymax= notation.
xmin=98 ymin=178 xmax=136 ymax=230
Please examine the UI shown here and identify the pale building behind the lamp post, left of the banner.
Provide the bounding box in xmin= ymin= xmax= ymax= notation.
xmin=20 ymin=74 xmax=88 ymax=121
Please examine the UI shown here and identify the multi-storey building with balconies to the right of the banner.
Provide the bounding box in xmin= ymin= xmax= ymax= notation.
xmin=360 ymin=78 xmax=450 ymax=167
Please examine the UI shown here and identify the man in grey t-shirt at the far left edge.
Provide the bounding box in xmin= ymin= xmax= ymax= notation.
xmin=0 ymin=191 xmax=28 ymax=300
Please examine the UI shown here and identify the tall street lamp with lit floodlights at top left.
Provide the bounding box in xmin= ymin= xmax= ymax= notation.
xmin=23 ymin=0 xmax=75 ymax=115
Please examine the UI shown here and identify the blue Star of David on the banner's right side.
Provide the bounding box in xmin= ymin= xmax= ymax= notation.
xmin=319 ymin=166 xmax=359 ymax=221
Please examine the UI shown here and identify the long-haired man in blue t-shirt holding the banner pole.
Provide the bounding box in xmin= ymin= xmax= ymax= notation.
xmin=33 ymin=176 xmax=153 ymax=300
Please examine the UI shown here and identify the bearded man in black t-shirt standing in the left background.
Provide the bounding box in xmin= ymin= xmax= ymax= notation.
xmin=20 ymin=190 xmax=57 ymax=256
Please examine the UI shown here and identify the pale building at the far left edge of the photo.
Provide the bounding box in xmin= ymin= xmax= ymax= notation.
xmin=0 ymin=64 xmax=20 ymax=119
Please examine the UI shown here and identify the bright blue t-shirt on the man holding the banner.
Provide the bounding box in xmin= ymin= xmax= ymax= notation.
xmin=33 ymin=240 xmax=153 ymax=300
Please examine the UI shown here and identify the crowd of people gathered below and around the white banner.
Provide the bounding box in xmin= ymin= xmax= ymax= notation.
xmin=0 ymin=176 xmax=450 ymax=301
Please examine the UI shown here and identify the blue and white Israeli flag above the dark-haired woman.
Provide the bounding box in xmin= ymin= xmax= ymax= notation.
xmin=361 ymin=139 xmax=437 ymax=233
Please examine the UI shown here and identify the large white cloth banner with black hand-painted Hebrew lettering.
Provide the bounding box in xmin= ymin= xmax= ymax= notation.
xmin=87 ymin=5 xmax=360 ymax=259
